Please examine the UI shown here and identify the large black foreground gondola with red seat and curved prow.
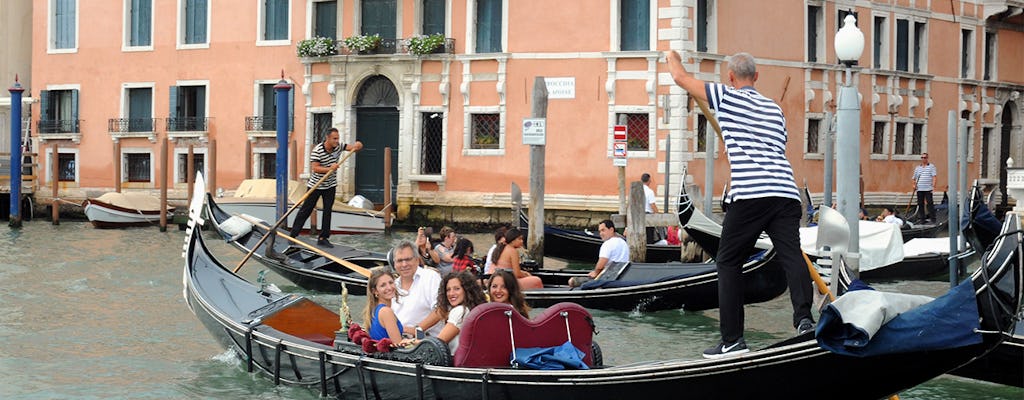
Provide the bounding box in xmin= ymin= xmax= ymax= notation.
xmin=182 ymin=175 xmax=1022 ymax=400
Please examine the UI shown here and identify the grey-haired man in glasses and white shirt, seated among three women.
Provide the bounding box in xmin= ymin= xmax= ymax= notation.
xmin=391 ymin=240 xmax=442 ymax=336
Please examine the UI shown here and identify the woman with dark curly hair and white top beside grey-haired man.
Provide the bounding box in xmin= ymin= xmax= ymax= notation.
xmin=417 ymin=271 xmax=487 ymax=354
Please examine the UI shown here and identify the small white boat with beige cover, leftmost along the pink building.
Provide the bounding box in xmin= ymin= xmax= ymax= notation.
xmin=82 ymin=191 xmax=174 ymax=228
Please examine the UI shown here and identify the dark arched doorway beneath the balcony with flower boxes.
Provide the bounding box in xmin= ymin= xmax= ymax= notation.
xmin=355 ymin=75 xmax=398 ymax=206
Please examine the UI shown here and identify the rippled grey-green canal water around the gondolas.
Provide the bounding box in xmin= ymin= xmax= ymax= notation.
xmin=0 ymin=220 xmax=1024 ymax=400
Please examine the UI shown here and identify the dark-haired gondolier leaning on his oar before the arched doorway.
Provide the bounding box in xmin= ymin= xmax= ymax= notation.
xmin=290 ymin=128 xmax=362 ymax=248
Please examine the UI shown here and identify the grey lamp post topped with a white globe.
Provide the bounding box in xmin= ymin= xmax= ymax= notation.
xmin=834 ymin=14 xmax=864 ymax=276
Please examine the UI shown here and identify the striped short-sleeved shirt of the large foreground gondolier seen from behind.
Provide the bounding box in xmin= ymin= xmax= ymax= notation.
xmin=705 ymin=83 xmax=800 ymax=203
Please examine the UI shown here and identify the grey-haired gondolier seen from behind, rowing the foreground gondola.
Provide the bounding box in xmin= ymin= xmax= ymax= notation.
xmin=667 ymin=51 xmax=814 ymax=358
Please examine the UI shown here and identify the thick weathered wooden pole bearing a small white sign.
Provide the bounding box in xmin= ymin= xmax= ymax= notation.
xmin=526 ymin=77 xmax=548 ymax=268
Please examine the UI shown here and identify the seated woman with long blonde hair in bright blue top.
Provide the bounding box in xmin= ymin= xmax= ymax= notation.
xmin=362 ymin=267 xmax=402 ymax=345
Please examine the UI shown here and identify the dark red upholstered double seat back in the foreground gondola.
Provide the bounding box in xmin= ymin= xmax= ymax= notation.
xmin=454 ymin=303 xmax=594 ymax=367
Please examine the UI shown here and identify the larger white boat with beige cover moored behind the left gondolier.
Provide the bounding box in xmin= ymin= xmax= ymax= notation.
xmin=217 ymin=179 xmax=384 ymax=234
